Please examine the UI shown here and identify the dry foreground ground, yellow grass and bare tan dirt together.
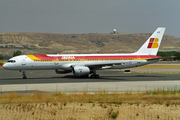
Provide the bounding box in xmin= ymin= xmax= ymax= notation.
xmin=0 ymin=89 xmax=180 ymax=120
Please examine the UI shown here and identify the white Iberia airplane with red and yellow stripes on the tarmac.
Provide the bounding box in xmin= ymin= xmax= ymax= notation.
xmin=3 ymin=27 xmax=165 ymax=79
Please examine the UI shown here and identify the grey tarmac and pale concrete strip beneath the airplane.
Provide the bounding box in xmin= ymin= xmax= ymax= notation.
xmin=0 ymin=68 xmax=180 ymax=93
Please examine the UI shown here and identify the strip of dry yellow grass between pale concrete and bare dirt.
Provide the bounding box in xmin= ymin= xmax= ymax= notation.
xmin=0 ymin=88 xmax=180 ymax=106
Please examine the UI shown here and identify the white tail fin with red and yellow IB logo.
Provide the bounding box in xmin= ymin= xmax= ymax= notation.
xmin=135 ymin=28 xmax=166 ymax=55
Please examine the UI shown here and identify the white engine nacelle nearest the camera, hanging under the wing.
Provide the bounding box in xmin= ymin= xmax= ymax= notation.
xmin=72 ymin=66 xmax=90 ymax=76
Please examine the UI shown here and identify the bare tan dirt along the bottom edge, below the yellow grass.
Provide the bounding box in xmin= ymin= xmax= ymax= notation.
xmin=0 ymin=103 xmax=180 ymax=120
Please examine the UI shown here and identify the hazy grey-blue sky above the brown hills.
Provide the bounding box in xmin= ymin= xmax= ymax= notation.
xmin=0 ymin=0 xmax=180 ymax=38
